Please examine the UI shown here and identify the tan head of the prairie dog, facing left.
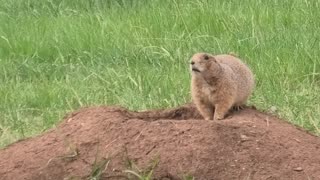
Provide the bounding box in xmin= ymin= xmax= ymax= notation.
xmin=190 ymin=53 xmax=220 ymax=75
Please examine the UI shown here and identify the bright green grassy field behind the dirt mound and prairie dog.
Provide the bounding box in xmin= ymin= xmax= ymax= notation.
xmin=0 ymin=0 xmax=320 ymax=147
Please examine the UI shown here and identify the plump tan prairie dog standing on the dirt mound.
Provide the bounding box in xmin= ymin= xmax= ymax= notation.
xmin=190 ymin=53 xmax=254 ymax=120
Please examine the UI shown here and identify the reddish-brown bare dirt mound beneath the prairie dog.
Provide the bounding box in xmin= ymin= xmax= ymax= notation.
xmin=0 ymin=105 xmax=320 ymax=180
